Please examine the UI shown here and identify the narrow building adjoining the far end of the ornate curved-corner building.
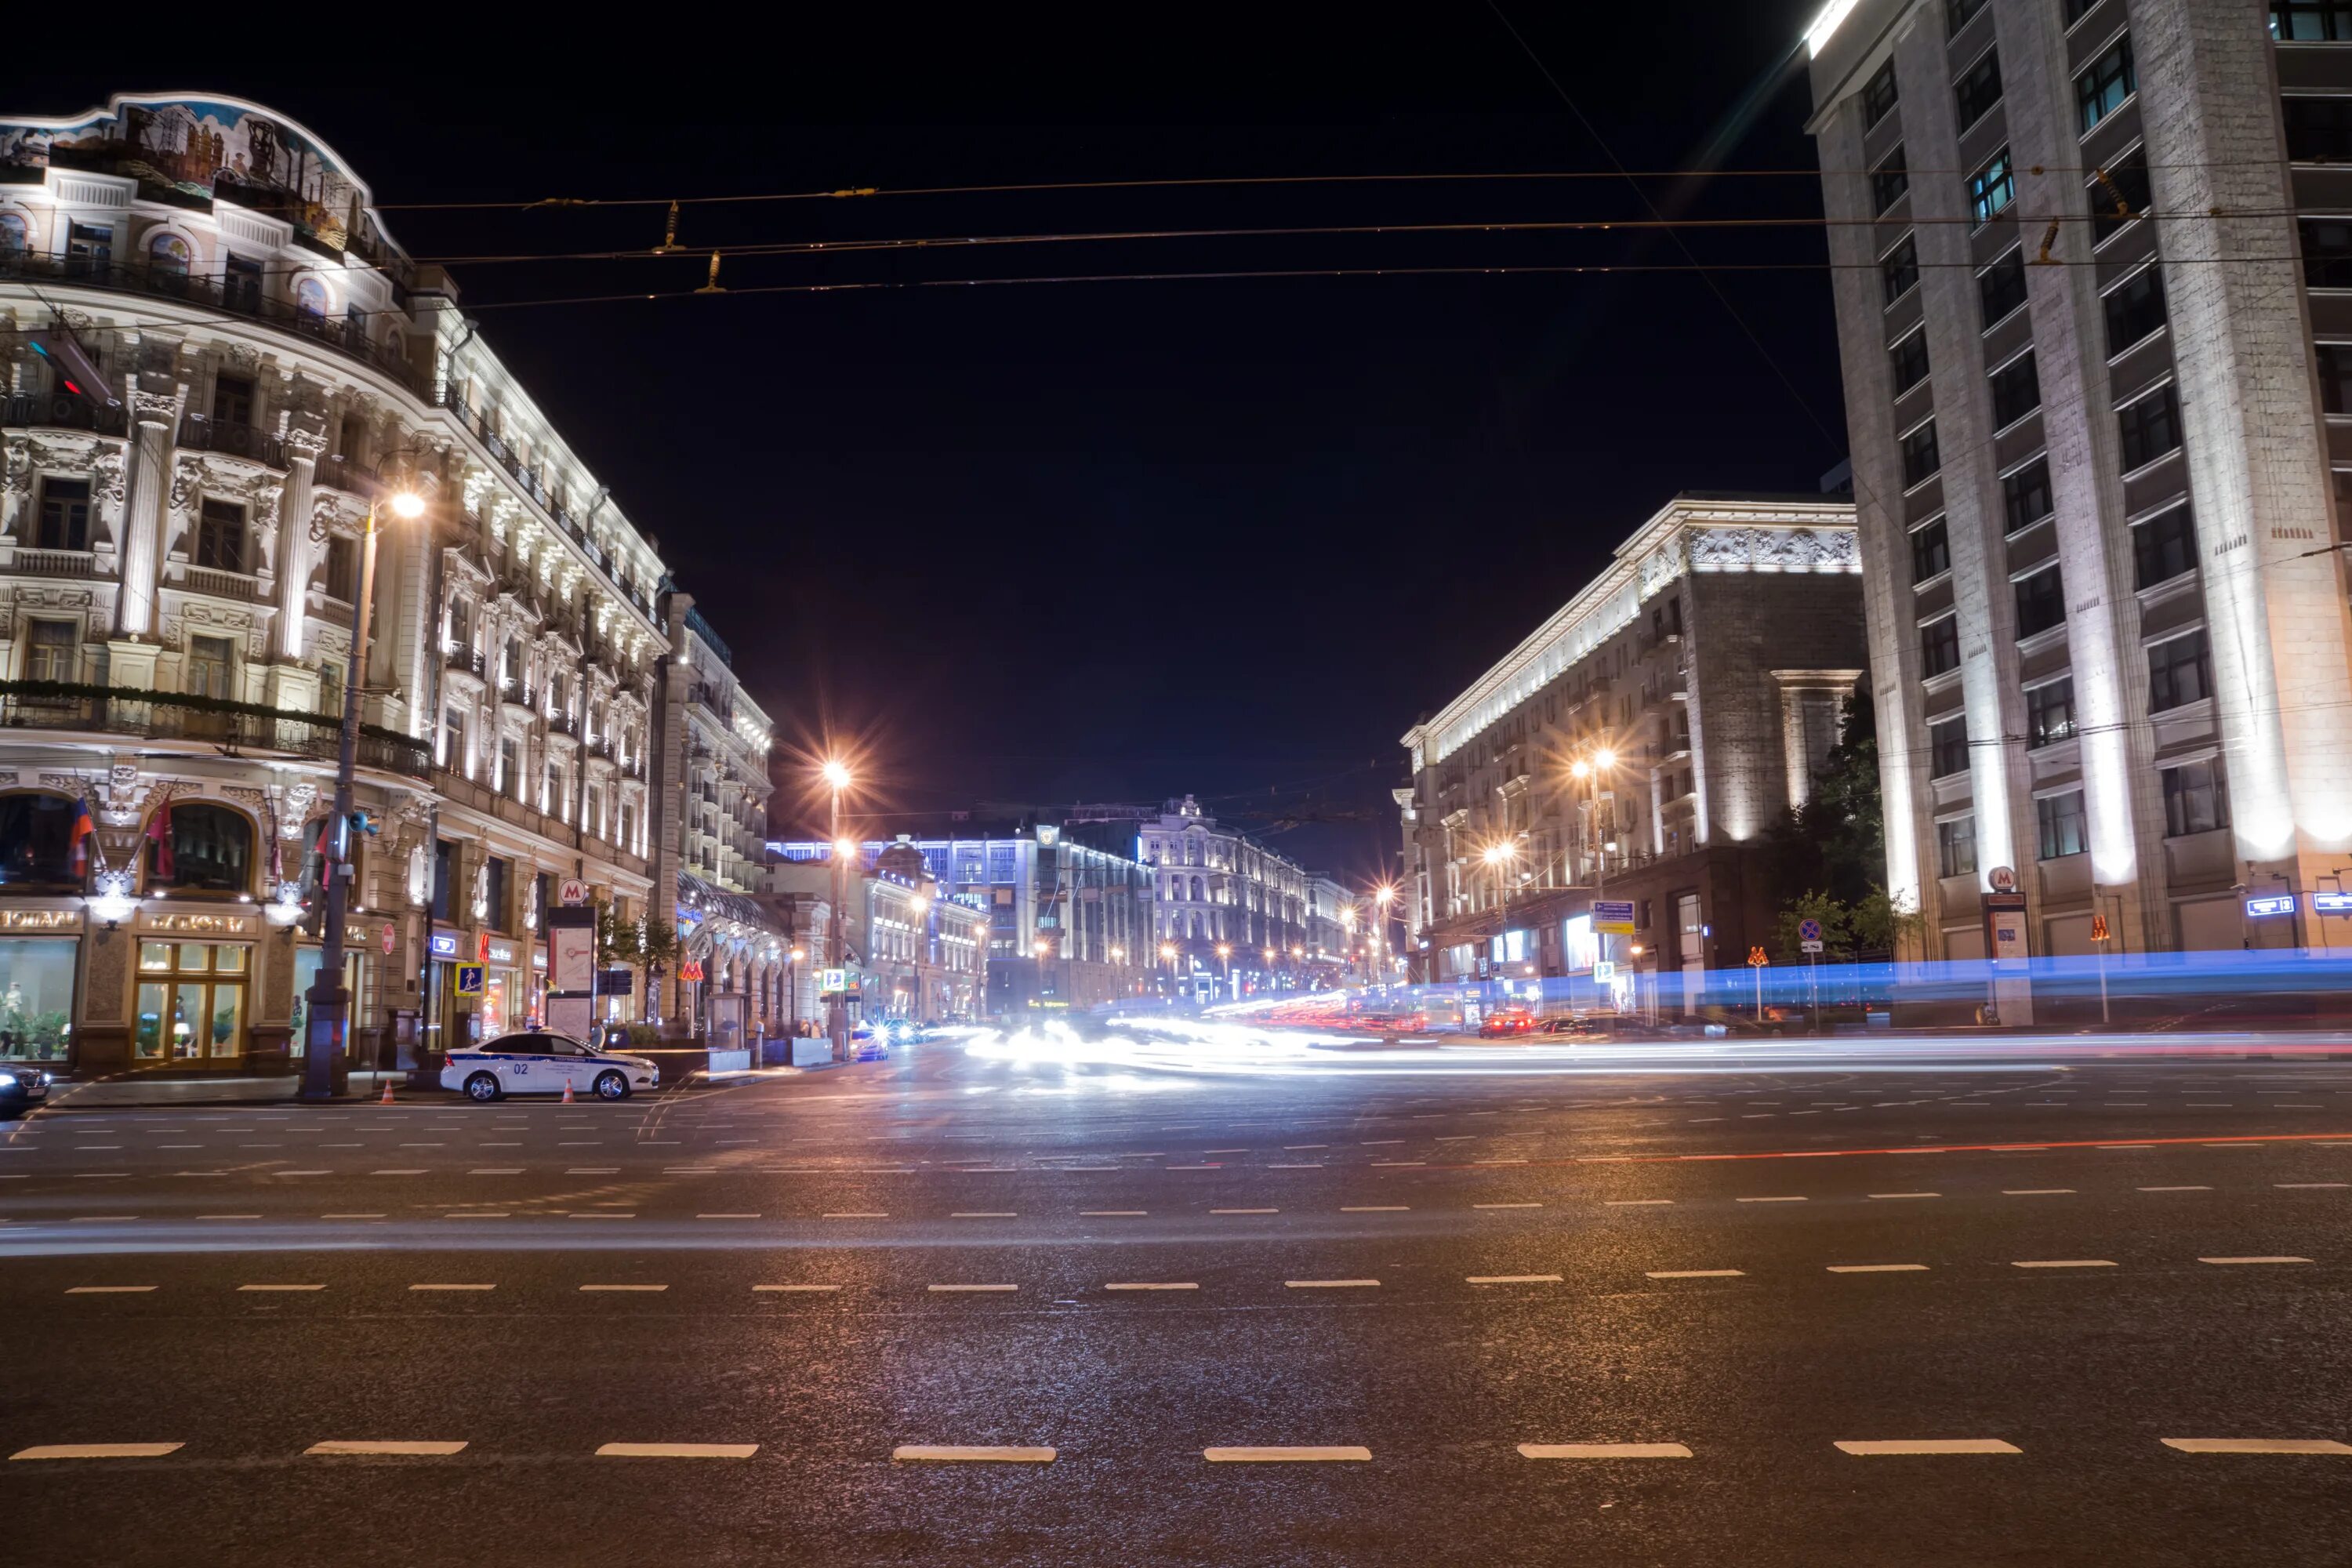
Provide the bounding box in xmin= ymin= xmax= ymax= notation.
xmin=654 ymin=588 xmax=790 ymax=1039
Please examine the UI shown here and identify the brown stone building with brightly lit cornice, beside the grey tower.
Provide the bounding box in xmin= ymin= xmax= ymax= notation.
xmin=1397 ymin=494 xmax=1863 ymax=1011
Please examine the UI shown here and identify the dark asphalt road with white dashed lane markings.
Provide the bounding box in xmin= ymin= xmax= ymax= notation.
xmin=0 ymin=1044 xmax=2352 ymax=1566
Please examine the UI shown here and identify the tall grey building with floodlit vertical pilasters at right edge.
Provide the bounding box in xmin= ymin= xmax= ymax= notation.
xmin=1809 ymin=0 xmax=2352 ymax=982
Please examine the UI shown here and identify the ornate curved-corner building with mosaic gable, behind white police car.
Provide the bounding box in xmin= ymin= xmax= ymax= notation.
xmin=0 ymin=96 xmax=753 ymax=1072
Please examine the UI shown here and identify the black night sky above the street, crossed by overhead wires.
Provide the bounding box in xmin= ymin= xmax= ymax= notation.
xmin=27 ymin=0 xmax=1844 ymax=879
